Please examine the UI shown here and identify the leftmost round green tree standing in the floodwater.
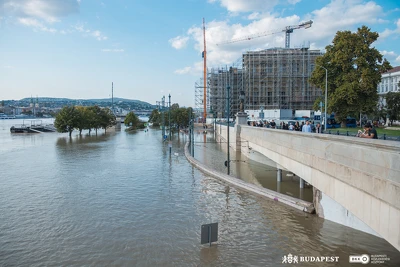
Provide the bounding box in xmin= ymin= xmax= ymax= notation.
xmin=54 ymin=106 xmax=80 ymax=136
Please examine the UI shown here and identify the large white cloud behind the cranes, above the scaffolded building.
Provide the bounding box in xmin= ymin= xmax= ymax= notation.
xmin=179 ymin=0 xmax=390 ymax=75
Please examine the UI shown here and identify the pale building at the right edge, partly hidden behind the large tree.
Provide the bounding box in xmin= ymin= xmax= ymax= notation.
xmin=378 ymin=66 xmax=400 ymax=106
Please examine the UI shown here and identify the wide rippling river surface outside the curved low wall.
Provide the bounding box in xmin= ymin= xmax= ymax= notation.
xmin=0 ymin=120 xmax=400 ymax=266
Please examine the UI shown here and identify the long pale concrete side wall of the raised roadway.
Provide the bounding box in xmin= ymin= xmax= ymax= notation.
xmin=241 ymin=126 xmax=400 ymax=250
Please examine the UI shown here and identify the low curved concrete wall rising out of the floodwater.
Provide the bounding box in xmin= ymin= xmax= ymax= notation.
xmin=185 ymin=143 xmax=315 ymax=213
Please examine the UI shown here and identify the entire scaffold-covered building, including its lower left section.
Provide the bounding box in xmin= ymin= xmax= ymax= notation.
xmin=195 ymin=48 xmax=322 ymax=118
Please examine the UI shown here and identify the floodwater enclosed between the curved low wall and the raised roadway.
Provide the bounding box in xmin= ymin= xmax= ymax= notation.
xmin=194 ymin=131 xmax=313 ymax=202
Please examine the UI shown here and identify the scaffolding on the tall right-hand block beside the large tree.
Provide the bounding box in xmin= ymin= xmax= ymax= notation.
xmin=242 ymin=48 xmax=322 ymax=110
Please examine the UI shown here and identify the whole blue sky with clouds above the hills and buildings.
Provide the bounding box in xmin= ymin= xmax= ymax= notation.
xmin=0 ymin=0 xmax=400 ymax=106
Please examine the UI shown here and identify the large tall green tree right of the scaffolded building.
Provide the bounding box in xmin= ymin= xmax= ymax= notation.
xmin=310 ymin=26 xmax=391 ymax=124
